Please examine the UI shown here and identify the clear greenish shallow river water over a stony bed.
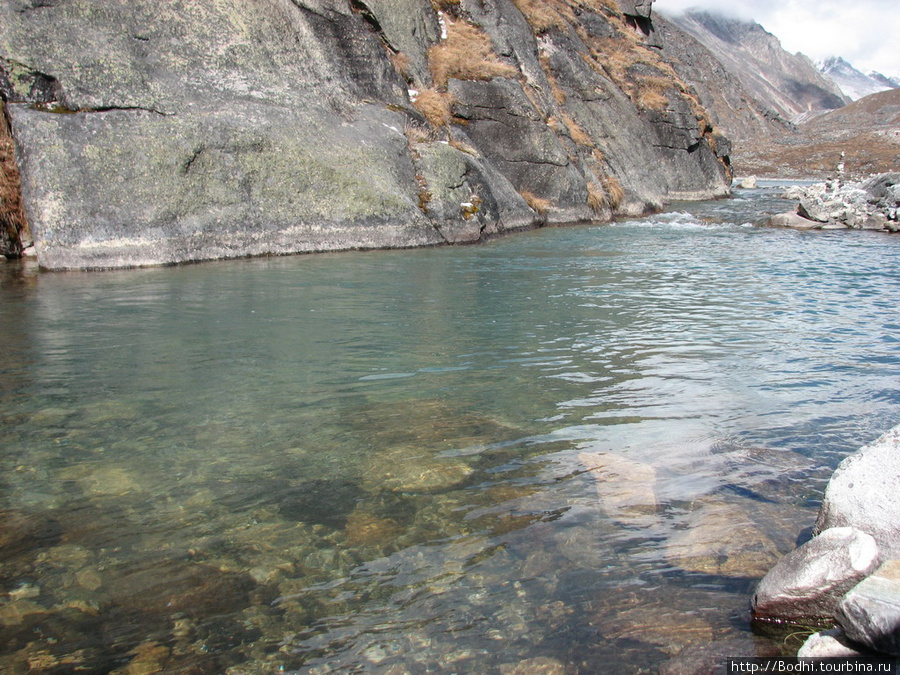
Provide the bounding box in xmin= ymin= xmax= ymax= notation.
xmin=0 ymin=182 xmax=900 ymax=675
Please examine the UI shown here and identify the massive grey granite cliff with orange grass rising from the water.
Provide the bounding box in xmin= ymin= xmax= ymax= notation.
xmin=0 ymin=0 xmax=730 ymax=269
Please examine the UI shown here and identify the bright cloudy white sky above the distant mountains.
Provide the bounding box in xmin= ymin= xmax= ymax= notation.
xmin=653 ymin=0 xmax=900 ymax=77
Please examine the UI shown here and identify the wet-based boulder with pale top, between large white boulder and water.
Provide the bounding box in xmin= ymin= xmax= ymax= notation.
xmin=752 ymin=527 xmax=880 ymax=621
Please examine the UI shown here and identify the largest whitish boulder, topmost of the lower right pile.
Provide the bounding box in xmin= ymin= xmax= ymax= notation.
xmin=815 ymin=427 xmax=900 ymax=558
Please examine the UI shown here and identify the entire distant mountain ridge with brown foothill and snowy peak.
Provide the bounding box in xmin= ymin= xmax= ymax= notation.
xmin=655 ymin=11 xmax=900 ymax=178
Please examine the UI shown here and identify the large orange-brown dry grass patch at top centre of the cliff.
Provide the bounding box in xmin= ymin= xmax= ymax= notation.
xmin=428 ymin=21 xmax=519 ymax=90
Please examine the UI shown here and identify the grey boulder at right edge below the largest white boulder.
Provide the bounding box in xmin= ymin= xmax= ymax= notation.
xmin=837 ymin=560 xmax=900 ymax=656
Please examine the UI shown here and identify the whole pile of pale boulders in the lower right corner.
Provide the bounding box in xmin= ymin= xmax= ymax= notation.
xmin=751 ymin=426 xmax=900 ymax=657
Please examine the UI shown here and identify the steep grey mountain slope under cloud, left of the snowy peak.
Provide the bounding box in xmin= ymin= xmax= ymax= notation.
xmin=669 ymin=11 xmax=849 ymax=121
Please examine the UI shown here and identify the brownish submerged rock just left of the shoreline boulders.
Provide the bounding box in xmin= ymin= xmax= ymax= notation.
xmin=666 ymin=501 xmax=779 ymax=577
